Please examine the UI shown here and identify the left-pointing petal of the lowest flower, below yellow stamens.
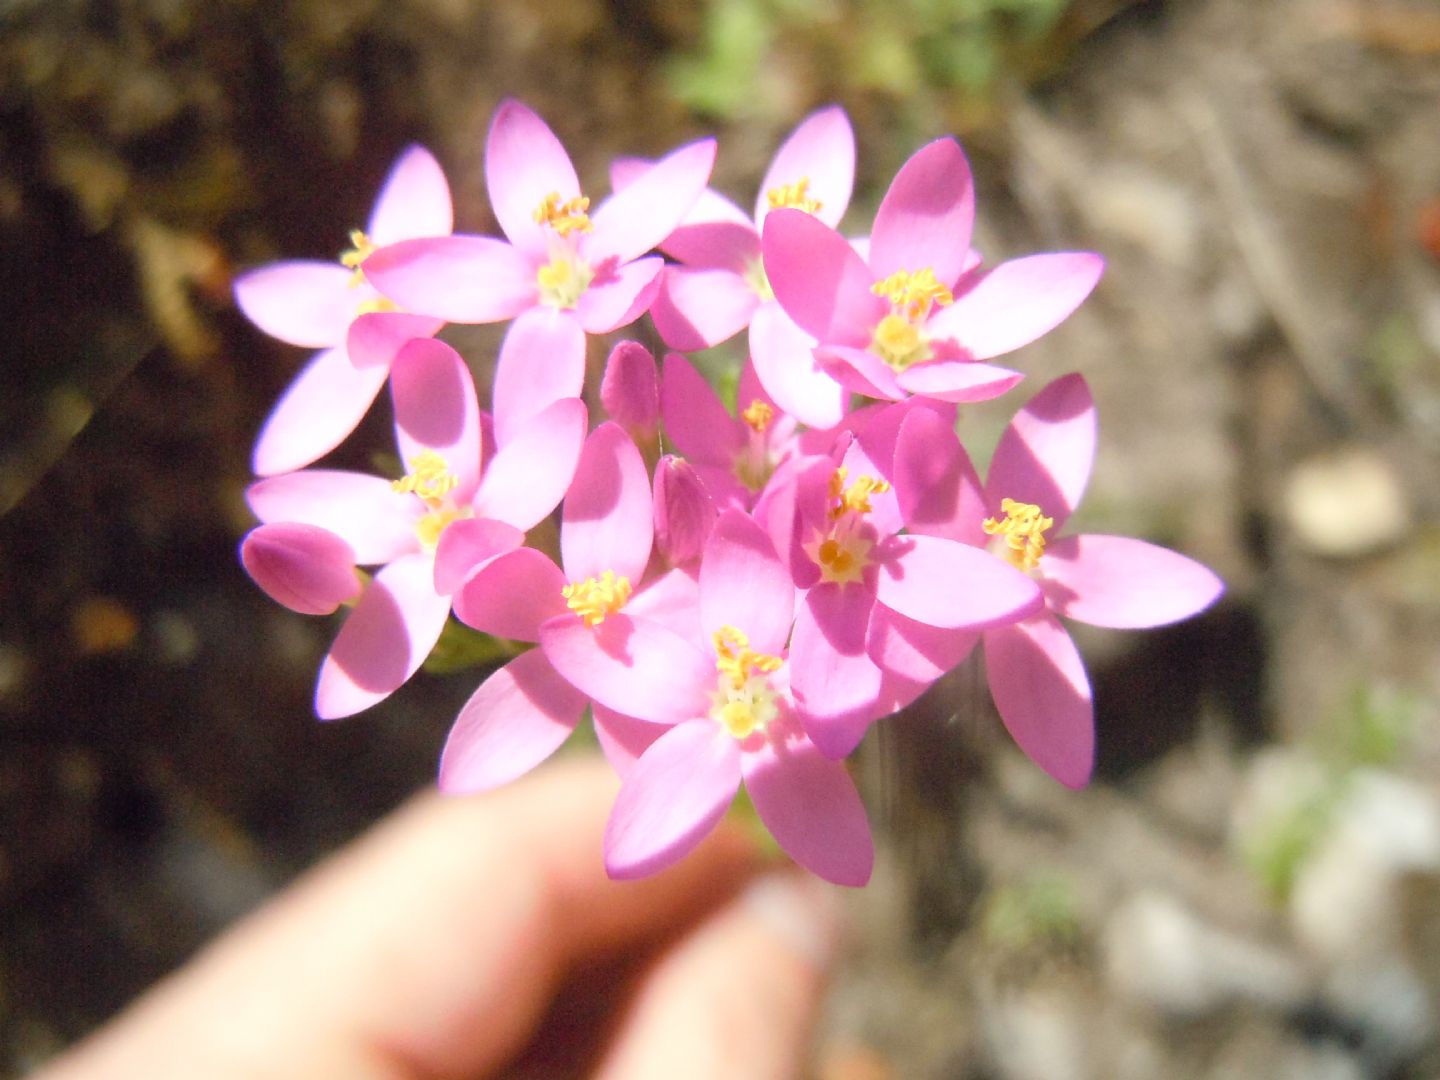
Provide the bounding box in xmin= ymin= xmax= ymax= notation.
xmin=540 ymin=612 xmax=716 ymax=724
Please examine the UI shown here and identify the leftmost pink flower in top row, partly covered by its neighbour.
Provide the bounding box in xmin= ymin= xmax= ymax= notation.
xmin=235 ymin=147 xmax=452 ymax=477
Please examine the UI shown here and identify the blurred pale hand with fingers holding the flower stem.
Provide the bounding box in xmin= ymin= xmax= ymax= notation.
xmin=36 ymin=760 xmax=837 ymax=1080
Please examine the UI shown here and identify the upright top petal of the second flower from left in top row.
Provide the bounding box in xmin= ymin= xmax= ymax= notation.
xmin=485 ymin=99 xmax=580 ymax=256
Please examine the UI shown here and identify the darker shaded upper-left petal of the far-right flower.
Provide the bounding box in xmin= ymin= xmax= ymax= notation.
xmin=894 ymin=409 xmax=989 ymax=546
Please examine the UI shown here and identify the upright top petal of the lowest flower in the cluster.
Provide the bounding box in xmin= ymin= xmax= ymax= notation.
xmin=700 ymin=510 xmax=795 ymax=655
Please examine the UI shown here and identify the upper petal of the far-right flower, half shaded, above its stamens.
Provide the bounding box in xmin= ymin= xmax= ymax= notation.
xmin=985 ymin=374 xmax=1096 ymax=530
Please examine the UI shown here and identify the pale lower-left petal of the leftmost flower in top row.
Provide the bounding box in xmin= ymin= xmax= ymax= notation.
xmin=252 ymin=348 xmax=387 ymax=477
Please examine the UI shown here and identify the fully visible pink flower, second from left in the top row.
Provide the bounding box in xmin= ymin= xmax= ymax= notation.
xmin=366 ymin=101 xmax=714 ymax=438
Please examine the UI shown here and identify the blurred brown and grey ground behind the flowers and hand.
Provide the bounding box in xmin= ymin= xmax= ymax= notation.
xmin=0 ymin=0 xmax=1440 ymax=1080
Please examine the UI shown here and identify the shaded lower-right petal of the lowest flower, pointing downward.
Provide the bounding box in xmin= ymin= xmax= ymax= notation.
xmin=740 ymin=737 xmax=876 ymax=887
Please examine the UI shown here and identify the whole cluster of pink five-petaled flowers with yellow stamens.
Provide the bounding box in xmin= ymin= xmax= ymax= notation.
xmin=236 ymin=101 xmax=1223 ymax=886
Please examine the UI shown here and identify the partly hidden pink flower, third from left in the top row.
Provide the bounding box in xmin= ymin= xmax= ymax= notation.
xmin=633 ymin=105 xmax=855 ymax=428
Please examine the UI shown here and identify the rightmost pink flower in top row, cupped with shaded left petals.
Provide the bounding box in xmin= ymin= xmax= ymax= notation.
xmin=762 ymin=138 xmax=1103 ymax=402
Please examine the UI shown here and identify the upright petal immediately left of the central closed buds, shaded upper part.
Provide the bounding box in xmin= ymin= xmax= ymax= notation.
xmin=560 ymin=422 xmax=655 ymax=585
